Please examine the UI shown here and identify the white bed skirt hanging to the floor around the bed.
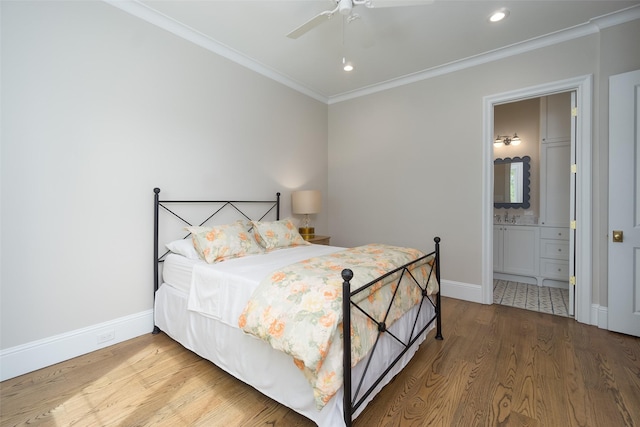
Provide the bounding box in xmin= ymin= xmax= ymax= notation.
xmin=155 ymin=284 xmax=435 ymax=427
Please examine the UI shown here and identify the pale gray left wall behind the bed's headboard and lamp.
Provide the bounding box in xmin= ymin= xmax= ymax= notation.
xmin=0 ymin=2 xmax=328 ymax=349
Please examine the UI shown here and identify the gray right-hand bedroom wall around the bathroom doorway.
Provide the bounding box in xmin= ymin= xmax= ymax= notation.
xmin=329 ymin=20 xmax=640 ymax=306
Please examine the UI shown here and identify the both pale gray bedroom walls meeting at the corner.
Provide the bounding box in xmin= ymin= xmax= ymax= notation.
xmin=0 ymin=2 xmax=640 ymax=364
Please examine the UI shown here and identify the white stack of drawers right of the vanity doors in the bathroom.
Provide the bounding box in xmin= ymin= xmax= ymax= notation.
xmin=540 ymin=227 xmax=570 ymax=282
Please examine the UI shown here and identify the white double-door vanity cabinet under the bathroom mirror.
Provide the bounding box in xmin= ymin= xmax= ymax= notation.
xmin=493 ymin=225 xmax=540 ymax=277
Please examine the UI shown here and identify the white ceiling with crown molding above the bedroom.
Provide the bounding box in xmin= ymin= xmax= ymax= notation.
xmin=111 ymin=0 xmax=640 ymax=103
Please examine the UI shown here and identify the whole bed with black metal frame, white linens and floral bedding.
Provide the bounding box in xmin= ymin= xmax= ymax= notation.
xmin=153 ymin=188 xmax=442 ymax=427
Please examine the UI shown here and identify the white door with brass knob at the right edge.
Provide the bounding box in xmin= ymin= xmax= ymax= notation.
xmin=607 ymin=70 xmax=640 ymax=336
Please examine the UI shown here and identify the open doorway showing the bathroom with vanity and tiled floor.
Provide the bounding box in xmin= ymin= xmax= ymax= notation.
xmin=493 ymin=96 xmax=575 ymax=317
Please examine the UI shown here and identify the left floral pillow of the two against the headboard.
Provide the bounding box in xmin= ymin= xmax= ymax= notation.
xmin=186 ymin=221 xmax=263 ymax=264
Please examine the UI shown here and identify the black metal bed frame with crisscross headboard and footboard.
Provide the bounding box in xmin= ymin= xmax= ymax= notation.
xmin=153 ymin=188 xmax=443 ymax=427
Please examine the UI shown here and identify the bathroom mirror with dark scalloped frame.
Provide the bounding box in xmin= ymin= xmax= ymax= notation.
xmin=493 ymin=156 xmax=531 ymax=209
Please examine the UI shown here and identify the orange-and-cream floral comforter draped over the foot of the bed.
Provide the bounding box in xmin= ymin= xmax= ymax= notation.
xmin=238 ymin=244 xmax=438 ymax=408
